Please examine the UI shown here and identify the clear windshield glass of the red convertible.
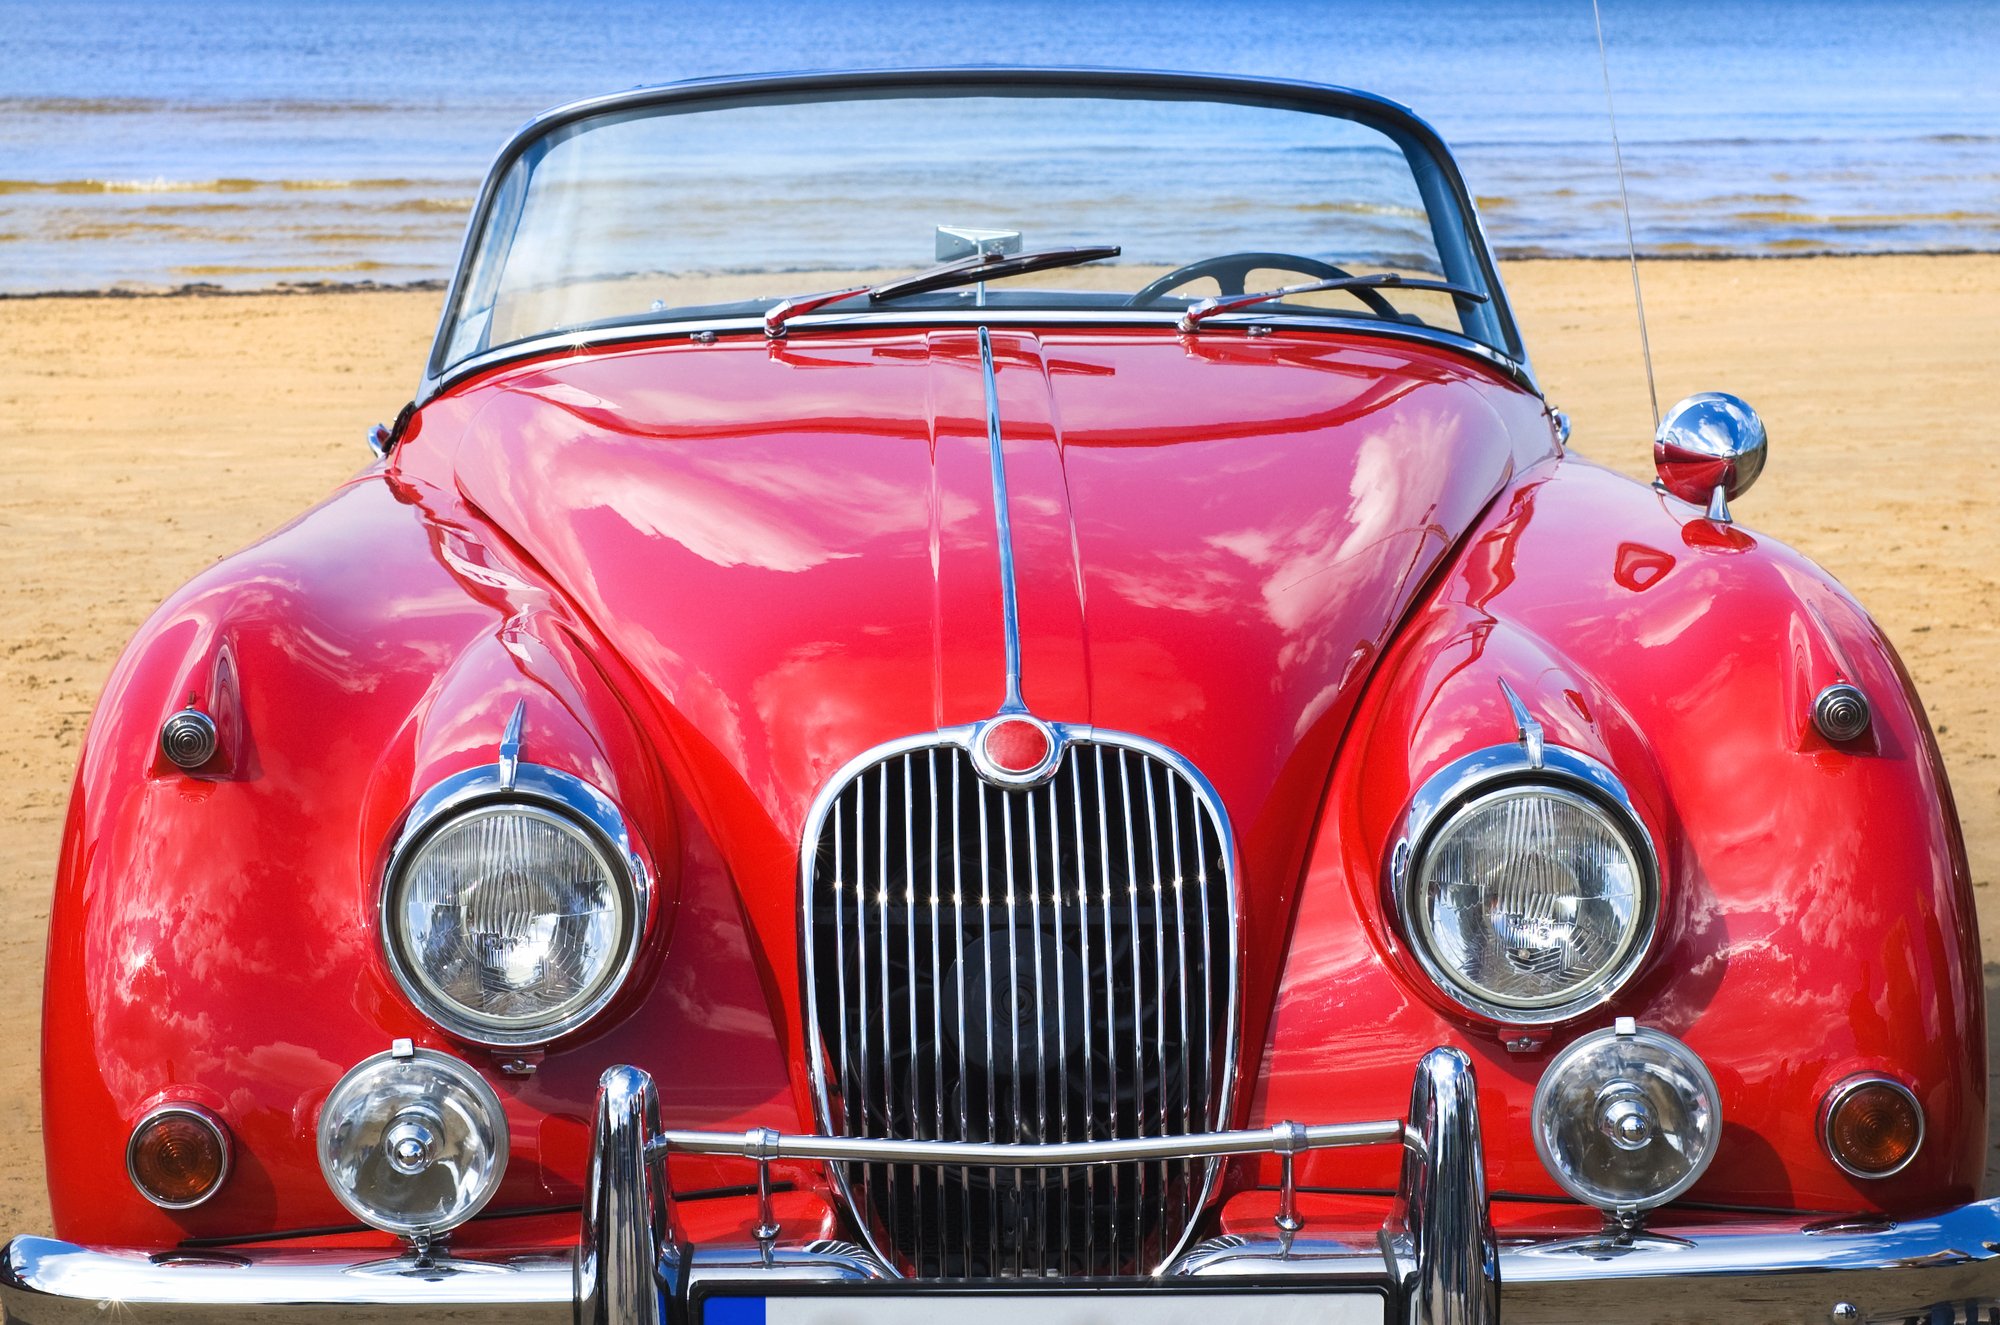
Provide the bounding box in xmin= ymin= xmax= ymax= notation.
xmin=436 ymin=88 xmax=1506 ymax=370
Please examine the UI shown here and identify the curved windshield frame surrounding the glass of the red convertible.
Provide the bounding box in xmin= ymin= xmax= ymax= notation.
xmin=414 ymin=66 xmax=1542 ymax=408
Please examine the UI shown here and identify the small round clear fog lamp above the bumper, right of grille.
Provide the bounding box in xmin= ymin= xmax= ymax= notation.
xmin=1532 ymin=1017 xmax=1722 ymax=1219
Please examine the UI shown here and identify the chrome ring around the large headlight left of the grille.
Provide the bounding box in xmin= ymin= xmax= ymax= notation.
xmin=378 ymin=763 xmax=652 ymax=1049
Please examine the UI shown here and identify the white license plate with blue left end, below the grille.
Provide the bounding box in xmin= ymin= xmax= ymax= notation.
xmin=702 ymin=1289 xmax=1388 ymax=1325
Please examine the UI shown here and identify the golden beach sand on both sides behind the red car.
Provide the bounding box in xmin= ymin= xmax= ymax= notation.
xmin=0 ymin=256 xmax=2000 ymax=1233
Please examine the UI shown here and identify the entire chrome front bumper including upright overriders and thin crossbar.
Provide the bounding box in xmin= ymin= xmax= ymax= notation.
xmin=11 ymin=1049 xmax=2000 ymax=1325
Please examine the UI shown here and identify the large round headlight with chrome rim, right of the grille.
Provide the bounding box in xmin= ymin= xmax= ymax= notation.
xmin=1398 ymin=747 xmax=1658 ymax=1023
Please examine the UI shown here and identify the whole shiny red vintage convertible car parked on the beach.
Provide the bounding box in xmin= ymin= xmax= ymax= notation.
xmin=0 ymin=68 xmax=2000 ymax=1325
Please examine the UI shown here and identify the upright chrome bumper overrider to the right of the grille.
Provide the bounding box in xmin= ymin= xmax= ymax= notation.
xmin=1384 ymin=1049 xmax=1500 ymax=1325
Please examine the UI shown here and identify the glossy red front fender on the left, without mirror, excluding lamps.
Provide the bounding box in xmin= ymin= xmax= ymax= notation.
xmin=42 ymin=470 xmax=824 ymax=1247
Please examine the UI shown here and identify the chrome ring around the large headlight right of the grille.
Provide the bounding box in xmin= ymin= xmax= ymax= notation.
xmin=1388 ymin=745 xmax=1660 ymax=1027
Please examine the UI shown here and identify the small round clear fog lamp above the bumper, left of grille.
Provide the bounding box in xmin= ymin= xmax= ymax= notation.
xmin=318 ymin=1047 xmax=508 ymax=1239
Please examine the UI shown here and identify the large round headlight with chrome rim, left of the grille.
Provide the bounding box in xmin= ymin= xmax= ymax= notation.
xmin=382 ymin=767 xmax=646 ymax=1045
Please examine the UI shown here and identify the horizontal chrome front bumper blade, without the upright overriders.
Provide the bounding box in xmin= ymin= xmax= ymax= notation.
xmin=11 ymin=1199 xmax=2000 ymax=1325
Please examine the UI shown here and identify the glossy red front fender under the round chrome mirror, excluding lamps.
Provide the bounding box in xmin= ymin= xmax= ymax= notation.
xmin=1252 ymin=458 xmax=1986 ymax=1215
